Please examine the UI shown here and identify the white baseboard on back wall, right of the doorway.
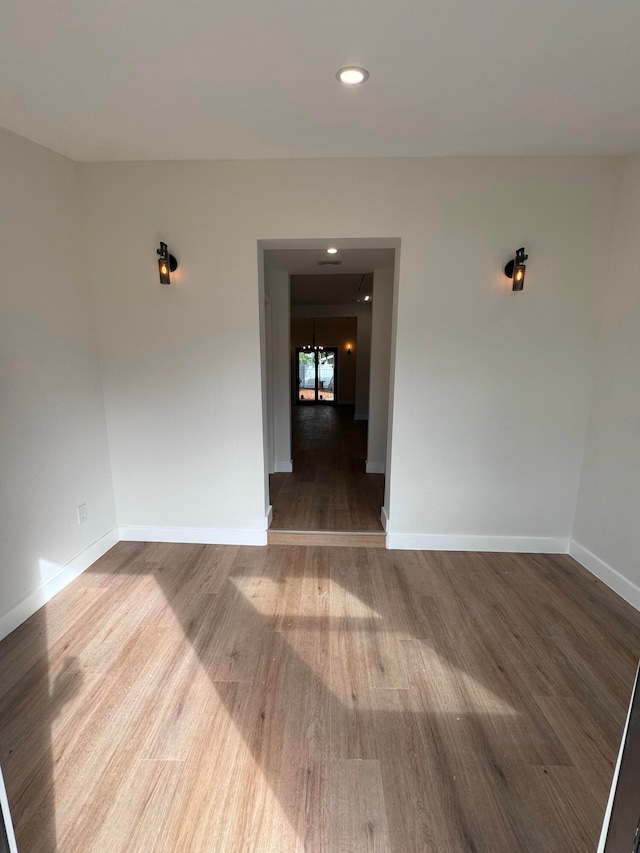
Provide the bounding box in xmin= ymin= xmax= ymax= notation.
xmin=383 ymin=522 xmax=569 ymax=554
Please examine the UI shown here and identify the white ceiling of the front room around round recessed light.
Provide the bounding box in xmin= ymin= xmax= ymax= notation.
xmin=0 ymin=0 xmax=640 ymax=160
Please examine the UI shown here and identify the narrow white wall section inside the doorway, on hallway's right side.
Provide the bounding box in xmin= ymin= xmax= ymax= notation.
xmin=367 ymin=268 xmax=393 ymax=474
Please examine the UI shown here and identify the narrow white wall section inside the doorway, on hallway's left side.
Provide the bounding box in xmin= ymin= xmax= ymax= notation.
xmin=265 ymin=269 xmax=291 ymax=472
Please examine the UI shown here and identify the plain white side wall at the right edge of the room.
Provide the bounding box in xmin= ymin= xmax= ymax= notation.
xmin=573 ymin=155 xmax=640 ymax=607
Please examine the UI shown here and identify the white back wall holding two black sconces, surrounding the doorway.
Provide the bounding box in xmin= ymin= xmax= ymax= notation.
xmin=81 ymin=157 xmax=618 ymax=548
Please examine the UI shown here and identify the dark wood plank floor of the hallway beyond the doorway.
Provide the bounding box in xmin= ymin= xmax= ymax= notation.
xmin=269 ymin=405 xmax=384 ymax=530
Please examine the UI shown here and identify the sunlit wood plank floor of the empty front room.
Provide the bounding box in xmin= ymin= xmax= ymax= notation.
xmin=0 ymin=543 xmax=640 ymax=853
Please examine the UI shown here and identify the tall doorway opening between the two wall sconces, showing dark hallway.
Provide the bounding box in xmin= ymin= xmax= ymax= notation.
xmin=259 ymin=240 xmax=399 ymax=536
